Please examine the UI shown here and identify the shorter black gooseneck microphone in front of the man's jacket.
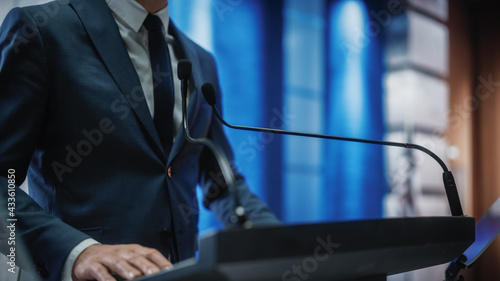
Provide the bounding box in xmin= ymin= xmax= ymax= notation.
xmin=177 ymin=59 xmax=252 ymax=229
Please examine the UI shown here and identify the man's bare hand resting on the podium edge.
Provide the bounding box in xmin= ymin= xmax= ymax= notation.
xmin=72 ymin=244 xmax=172 ymax=281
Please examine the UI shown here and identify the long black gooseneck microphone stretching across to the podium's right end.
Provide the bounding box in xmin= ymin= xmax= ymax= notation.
xmin=201 ymin=83 xmax=463 ymax=216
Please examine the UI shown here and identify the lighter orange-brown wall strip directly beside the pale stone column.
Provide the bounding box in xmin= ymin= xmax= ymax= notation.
xmin=447 ymin=1 xmax=474 ymax=215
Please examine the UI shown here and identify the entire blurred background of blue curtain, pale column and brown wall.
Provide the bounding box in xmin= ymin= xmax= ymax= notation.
xmin=0 ymin=0 xmax=500 ymax=281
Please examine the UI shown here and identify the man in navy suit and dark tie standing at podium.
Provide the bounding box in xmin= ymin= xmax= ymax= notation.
xmin=0 ymin=0 xmax=279 ymax=280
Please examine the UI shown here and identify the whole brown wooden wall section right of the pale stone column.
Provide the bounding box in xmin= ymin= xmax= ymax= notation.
xmin=448 ymin=1 xmax=500 ymax=281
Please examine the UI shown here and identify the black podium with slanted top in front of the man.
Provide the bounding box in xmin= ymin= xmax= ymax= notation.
xmin=137 ymin=216 xmax=475 ymax=281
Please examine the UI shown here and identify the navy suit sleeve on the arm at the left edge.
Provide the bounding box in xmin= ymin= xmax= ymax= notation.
xmin=0 ymin=8 xmax=89 ymax=280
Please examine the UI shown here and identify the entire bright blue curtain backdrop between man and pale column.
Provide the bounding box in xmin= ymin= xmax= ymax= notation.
xmin=169 ymin=0 xmax=386 ymax=232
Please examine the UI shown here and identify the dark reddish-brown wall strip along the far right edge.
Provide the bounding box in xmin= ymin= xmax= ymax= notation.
xmin=474 ymin=3 xmax=500 ymax=280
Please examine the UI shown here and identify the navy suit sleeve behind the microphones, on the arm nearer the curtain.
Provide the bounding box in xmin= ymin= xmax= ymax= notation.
xmin=195 ymin=55 xmax=281 ymax=228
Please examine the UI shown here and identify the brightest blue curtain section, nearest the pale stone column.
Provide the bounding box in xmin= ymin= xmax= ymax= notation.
xmin=325 ymin=1 xmax=386 ymax=220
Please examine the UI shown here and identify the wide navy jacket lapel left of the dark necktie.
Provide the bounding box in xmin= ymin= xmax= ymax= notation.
xmin=71 ymin=0 xmax=166 ymax=161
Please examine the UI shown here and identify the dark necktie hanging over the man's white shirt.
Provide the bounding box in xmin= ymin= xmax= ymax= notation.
xmin=144 ymin=14 xmax=174 ymax=156
